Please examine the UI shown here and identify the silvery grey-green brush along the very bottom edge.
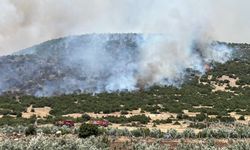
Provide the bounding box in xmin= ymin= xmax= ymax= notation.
xmin=0 ymin=129 xmax=250 ymax=150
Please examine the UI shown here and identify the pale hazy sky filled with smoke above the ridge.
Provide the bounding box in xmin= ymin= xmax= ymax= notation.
xmin=0 ymin=0 xmax=250 ymax=55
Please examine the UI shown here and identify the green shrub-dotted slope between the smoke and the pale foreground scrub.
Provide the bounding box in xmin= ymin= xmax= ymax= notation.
xmin=0 ymin=41 xmax=250 ymax=127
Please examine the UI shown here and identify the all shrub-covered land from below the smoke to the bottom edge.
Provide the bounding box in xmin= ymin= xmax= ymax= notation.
xmin=0 ymin=44 xmax=250 ymax=150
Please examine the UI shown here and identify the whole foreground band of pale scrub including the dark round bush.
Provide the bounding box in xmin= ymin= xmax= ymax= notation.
xmin=0 ymin=124 xmax=250 ymax=150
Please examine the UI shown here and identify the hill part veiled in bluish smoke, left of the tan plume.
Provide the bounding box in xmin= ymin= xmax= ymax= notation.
xmin=0 ymin=34 xmax=140 ymax=96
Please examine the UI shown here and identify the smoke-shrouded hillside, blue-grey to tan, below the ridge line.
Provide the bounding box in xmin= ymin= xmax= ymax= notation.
xmin=0 ymin=34 xmax=231 ymax=96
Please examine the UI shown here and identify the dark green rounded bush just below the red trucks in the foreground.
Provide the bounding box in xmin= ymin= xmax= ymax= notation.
xmin=78 ymin=124 xmax=99 ymax=138
